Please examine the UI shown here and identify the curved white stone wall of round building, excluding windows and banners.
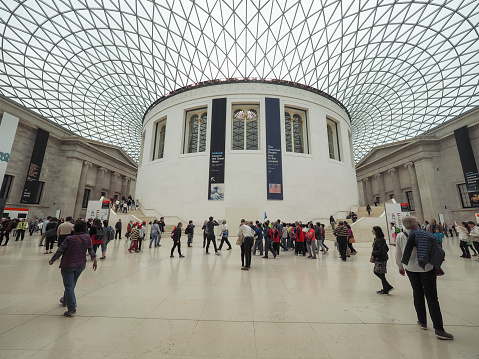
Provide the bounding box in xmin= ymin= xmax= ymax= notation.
xmin=136 ymin=83 xmax=358 ymax=225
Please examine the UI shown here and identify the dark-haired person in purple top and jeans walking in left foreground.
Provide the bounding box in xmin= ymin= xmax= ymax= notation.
xmin=48 ymin=221 xmax=97 ymax=317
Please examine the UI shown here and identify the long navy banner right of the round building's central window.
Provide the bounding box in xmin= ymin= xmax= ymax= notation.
xmin=265 ymin=97 xmax=283 ymax=200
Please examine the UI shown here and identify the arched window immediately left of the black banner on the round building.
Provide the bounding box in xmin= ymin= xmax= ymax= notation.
xmin=183 ymin=108 xmax=208 ymax=153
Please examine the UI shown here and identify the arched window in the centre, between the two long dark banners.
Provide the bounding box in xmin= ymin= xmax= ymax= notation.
xmin=232 ymin=105 xmax=259 ymax=150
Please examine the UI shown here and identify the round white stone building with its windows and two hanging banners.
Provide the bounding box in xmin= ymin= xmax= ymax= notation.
xmin=136 ymin=80 xmax=358 ymax=224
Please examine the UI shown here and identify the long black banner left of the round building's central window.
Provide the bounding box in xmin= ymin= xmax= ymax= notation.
xmin=208 ymin=98 xmax=226 ymax=201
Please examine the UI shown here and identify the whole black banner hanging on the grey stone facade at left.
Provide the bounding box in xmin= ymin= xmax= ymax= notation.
xmin=20 ymin=128 xmax=50 ymax=204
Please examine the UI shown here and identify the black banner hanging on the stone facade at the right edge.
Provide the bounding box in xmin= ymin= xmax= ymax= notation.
xmin=454 ymin=126 xmax=479 ymax=207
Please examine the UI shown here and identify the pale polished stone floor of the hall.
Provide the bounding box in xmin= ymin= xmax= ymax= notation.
xmin=0 ymin=236 xmax=479 ymax=359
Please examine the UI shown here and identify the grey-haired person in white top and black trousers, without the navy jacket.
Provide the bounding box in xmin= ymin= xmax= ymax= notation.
xmin=396 ymin=216 xmax=454 ymax=340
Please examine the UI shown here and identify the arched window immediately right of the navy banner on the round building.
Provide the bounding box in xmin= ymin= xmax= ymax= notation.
xmin=284 ymin=108 xmax=309 ymax=153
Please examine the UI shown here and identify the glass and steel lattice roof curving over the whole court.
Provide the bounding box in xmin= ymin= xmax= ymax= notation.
xmin=0 ymin=0 xmax=479 ymax=160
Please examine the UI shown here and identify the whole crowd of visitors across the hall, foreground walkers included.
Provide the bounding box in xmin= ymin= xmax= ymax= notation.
xmin=0 ymin=208 xmax=479 ymax=339
